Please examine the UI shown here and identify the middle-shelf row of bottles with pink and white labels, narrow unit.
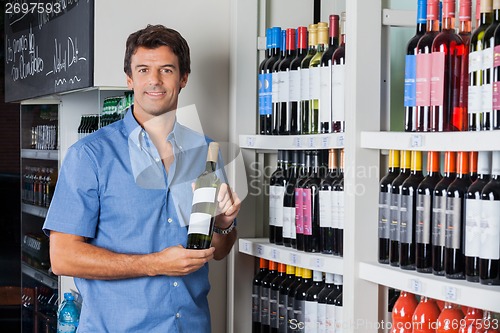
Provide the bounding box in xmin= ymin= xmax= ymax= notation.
xmin=269 ymin=149 xmax=344 ymax=256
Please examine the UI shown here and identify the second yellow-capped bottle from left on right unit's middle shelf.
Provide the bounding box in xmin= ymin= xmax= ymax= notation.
xmin=389 ymin=150 xmax=410 ymax=266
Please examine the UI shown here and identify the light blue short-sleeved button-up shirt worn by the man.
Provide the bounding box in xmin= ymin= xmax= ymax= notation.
xmin=43 ymin=107 xmax=224 ymax=333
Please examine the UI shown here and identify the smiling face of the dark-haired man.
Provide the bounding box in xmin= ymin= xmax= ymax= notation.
xmin=127 ymin=46 xmax=188 ymax=122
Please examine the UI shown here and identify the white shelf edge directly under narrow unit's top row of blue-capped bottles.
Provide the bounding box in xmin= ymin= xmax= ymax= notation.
xmin=240 ymin=133 xmax=345 ymax=150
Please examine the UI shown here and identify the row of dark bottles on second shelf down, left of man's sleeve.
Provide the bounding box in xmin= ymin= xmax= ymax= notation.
xmin=21 ymin=166 xmax=57 ymax=207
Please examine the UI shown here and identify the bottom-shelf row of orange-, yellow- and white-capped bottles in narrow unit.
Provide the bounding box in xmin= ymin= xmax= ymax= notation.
xmin=252 ymin=258 xmax=343 ymax=333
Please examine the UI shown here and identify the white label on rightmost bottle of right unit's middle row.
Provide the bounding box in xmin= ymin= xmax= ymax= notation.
xmin=479 ymin=200 xmax=500 ymax=260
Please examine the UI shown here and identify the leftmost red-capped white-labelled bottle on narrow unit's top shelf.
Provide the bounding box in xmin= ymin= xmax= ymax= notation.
xmin=277 ymin=29 xmax=295 ymax=135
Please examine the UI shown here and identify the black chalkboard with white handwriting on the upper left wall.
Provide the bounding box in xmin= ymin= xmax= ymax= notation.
xmin=4 ymin=0 xmax=94 ymax=102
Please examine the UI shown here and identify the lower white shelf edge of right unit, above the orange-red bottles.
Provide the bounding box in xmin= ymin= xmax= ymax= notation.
xmin=359 ymin=263 xmax=500 ymax=312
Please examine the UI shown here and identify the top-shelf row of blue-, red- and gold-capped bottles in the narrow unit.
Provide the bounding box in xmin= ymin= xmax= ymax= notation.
xmin=258 ymin=13 xmax=345 ymax=135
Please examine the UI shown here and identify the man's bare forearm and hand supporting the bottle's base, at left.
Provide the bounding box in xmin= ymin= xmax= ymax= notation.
xmin=50 ymin=231 xmax=215 ymax=280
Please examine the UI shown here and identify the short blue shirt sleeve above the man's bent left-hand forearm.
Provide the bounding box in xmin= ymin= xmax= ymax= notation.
xmin=43 ymin=146 xmax=99 ymax=238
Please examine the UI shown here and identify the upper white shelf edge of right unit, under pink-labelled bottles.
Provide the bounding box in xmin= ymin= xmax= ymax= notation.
xmin=361 ymin=131 xmax=500 ymax=151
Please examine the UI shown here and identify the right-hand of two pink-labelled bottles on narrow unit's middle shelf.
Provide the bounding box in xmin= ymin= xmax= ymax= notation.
xmin=297 ymin=150 xmax=321 ymax=252
